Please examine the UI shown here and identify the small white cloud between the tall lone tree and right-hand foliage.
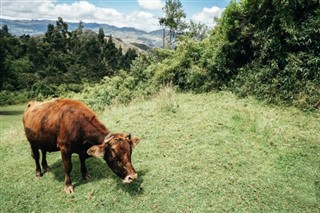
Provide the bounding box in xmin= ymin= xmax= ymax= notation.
xmin=191 ymin=6 xmax=224 ymax=27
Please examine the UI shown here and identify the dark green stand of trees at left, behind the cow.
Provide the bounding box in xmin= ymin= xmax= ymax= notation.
xmin=0 ymin=17 xmax=137 ymax=104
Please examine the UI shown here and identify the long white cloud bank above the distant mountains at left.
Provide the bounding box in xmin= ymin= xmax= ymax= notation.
xmin=1 ymin=0 xmax=159 ymax=31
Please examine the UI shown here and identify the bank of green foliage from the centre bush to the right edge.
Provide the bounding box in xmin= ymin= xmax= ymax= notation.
xmin=156 ymin=0 xmax=320 ymax=108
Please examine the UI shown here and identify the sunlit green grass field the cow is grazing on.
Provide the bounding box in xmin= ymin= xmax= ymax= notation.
xmin=0 ymin=89 xmax=320 ymax=212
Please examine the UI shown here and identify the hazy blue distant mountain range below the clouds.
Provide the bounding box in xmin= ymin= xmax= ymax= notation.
xmin=0 ymin=19 xmax=162 ymax=47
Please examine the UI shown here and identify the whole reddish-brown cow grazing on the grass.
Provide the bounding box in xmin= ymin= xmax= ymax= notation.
xmin=23 ymin=99 xmax=140 ymax=193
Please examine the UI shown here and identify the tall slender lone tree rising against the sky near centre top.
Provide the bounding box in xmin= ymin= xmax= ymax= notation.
xmin=159 ymin=0 xmax=187 ymax=47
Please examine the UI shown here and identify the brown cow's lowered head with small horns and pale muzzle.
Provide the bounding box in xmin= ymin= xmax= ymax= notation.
xmin=87 ymin=133 xmax=140 ymax=183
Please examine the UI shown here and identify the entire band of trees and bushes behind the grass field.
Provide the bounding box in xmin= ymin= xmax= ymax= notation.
xmin=0 ymin=0 xmax=320 ymax=110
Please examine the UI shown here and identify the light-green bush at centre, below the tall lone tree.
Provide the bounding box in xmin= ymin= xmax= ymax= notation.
xmin=155 ymin=38 xmax=214 ymax=92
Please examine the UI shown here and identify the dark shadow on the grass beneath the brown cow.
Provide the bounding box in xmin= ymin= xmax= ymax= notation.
xmin=44 ymin=155 xmax=147 ymax=196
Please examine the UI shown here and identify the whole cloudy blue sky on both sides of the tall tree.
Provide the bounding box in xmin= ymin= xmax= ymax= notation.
xmin=0 ymin=0 xmax=230 ymax=32
